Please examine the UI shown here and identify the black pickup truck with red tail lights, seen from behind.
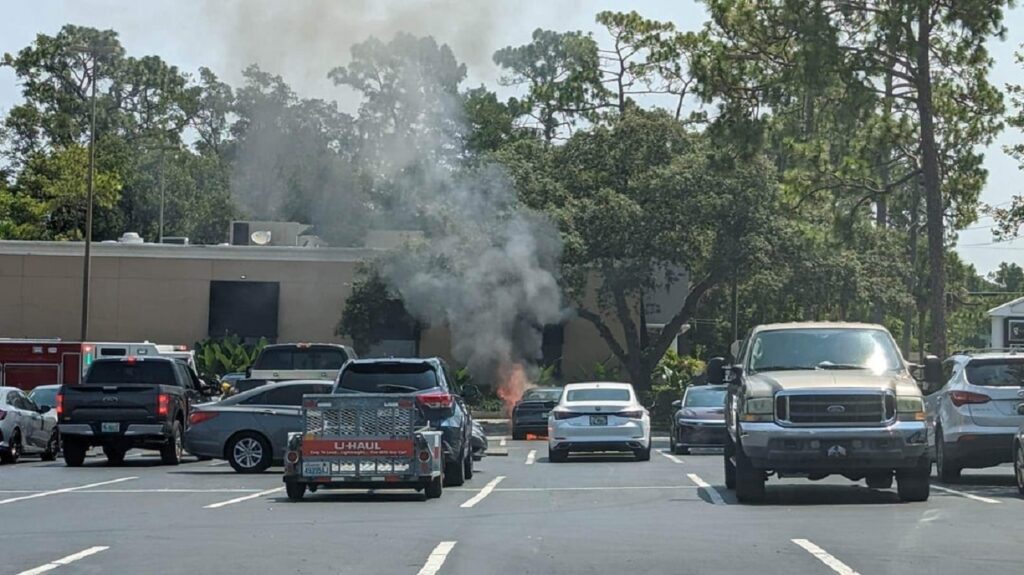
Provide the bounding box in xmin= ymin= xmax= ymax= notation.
xmin=57 ymin=357 xmax=209 ymax=467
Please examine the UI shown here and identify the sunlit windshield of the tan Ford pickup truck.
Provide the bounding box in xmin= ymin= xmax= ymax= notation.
xmin=749 ymin=327 xmax=903 ymax=373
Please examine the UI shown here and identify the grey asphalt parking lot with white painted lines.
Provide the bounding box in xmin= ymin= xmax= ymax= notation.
xmin=0 ymin=439 xmax=1024 ymax=575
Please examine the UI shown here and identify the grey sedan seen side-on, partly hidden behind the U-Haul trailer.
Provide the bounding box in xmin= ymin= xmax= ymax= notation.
xmin=185 ymin=380 xmax=334 ymax=473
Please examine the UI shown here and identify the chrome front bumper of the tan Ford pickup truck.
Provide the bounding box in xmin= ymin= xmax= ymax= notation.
xmin=739 ymin=415 xmax=928 ymax=473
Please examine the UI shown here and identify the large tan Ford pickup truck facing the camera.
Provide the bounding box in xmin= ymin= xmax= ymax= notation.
xmin=708 ymin=323 xmax=941 ymax=502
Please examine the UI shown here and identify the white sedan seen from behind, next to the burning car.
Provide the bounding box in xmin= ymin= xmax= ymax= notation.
xmin=548 ymin=383 xmax=650 ymax=462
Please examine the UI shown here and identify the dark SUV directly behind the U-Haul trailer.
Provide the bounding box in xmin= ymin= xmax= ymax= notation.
xmin=334 ymin=358 xmax=473 ymax=486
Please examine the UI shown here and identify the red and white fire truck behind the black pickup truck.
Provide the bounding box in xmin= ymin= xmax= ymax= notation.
xmin=0 ymin=339 xmax=187 ymax=391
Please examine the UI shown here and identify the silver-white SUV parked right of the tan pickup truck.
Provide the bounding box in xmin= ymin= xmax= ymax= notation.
xmin=925 ymin=350 xmax=1024 ymax=481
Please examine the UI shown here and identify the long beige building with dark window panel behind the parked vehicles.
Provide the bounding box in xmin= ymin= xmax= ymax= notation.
xmin=0 ymin=241 xmax=611 ymax=380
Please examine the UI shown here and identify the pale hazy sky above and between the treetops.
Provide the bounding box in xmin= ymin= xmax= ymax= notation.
xmin=0 ymin=0 xmax=1024 ymax=273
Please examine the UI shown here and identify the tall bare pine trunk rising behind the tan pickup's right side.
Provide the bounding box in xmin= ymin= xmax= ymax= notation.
xmin=918 ymin=7 xmax=946 ymax=357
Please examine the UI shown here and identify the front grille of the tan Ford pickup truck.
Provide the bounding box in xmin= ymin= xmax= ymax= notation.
xmin=775 ymin=393 xmax=896 ymax=426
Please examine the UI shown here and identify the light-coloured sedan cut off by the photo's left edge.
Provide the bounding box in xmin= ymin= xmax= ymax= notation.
xmin=0 ymin=388 xmax=57 ymax=463
